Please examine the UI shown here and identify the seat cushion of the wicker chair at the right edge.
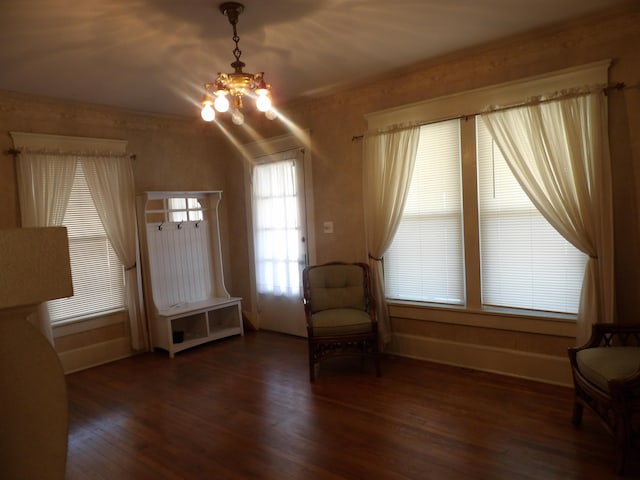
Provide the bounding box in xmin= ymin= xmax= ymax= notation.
xmin=576 ymin=347 xmax=640 ymax=392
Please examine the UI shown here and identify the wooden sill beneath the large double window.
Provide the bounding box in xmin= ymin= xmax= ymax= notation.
xmin=387 ymin=300 xmax=576 ymax=338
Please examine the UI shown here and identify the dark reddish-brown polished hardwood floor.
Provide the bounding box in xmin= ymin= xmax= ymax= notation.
xmin=67 ymin=332 xmax=636 ymax=480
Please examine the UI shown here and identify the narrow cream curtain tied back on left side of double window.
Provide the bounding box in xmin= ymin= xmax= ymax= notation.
xmin=362 ymin=126 xmax=420 ymax=346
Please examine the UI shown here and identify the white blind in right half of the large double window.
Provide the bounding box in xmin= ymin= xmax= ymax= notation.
xmin=477 ymin=117 xmax=586 ymax=314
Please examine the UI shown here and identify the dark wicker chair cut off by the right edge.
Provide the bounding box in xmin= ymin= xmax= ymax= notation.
xmin=569 ymin=324 xmax=640 ymax=475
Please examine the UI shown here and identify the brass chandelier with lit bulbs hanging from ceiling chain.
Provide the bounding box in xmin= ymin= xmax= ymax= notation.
xmin=200 ymin=2 xmax=277 ymax=125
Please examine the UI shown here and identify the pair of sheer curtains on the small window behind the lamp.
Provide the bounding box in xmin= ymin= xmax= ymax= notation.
xmin=17 ymin=149 xmax=148 ymax=350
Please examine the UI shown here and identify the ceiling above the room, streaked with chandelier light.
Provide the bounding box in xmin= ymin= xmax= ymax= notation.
xmin=0 ymin=0 xmax=632 ymax=116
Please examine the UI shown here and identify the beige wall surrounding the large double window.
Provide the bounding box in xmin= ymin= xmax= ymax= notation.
xmin=222 ymin=2 xmax=640 ymax=383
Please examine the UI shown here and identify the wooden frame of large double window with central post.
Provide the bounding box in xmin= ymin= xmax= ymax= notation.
xmin=365 ymin=59 xmax=611 ymax=330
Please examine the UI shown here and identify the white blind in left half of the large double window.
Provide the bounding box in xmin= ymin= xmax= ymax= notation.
xmin=384 ymin=120 xmax=465 ymax=305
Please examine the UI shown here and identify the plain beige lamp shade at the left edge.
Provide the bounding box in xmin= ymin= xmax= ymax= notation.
xmin=0 ymin=227 xmax=73 ymax=309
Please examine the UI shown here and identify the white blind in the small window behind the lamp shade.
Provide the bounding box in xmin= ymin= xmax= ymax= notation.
xmin=48 ymin=163 xmax=125 ymax=322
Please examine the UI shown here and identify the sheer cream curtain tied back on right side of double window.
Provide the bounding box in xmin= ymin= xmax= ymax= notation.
xmin=482 ymin=91 xmax=615 ymax=344
